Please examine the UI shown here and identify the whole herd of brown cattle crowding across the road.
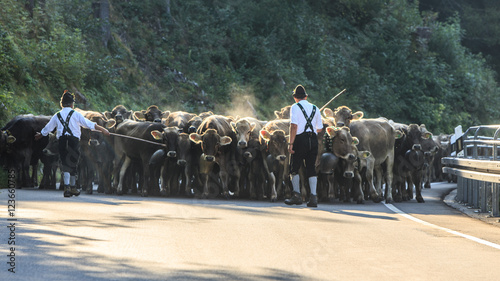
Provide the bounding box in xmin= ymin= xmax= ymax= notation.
xmin=0 ymin=105 xmax=449 ymax=203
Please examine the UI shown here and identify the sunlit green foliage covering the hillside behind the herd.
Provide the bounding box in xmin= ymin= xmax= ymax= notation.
xmin=0 ymin=0 xmax=500 ymax=133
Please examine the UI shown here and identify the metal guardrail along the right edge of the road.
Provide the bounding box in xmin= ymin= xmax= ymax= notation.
xmin=441 ymin=125 xmax=500 ymax=217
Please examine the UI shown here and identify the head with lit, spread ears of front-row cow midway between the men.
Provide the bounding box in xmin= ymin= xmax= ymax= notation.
xmin=189 ymin=129 xmax=232 ymax=162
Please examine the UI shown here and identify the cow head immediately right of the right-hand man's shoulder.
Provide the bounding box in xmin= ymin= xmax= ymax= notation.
xmin=326 ymin=126 xmax=359 ymax=160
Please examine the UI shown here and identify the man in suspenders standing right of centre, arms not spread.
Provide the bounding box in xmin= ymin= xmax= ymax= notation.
xmin=285 ymin=85 xmax=323 ymax=207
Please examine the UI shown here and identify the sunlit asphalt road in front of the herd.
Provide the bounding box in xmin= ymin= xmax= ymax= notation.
xmin=0 ymin=183 xmax=500 ymax=281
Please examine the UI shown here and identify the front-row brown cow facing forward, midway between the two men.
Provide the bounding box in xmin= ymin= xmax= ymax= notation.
xmin=189 ymin=115 xmax=240 ymax=199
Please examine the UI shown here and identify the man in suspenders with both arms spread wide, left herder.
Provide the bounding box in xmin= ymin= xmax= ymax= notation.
xmin=35 ymin=90 xmax=109 ymax=197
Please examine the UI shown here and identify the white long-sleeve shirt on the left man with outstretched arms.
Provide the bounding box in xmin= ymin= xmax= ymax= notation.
xmin=41 ymin=107 xmax=95 ymax=139
